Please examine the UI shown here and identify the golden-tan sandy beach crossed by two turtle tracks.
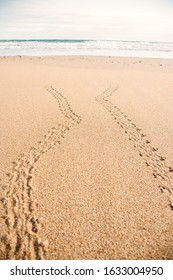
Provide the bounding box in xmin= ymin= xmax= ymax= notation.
xmin=0 ymin=56 xmax=173 ymax=260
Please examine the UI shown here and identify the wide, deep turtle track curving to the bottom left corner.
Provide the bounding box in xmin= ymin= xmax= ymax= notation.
xmin=0 ymin=86 xmax=82 ymax=260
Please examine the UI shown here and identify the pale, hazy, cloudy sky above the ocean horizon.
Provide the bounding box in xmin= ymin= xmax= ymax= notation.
xmin=0 ymin=0 xmax=173 ymax=42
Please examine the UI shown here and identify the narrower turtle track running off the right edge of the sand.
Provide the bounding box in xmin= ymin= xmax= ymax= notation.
xmin=95 ymin=86 xmax=173 ymax=209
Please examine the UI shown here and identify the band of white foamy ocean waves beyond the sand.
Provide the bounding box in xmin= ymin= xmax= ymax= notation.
xmin=0 ymin=40 xmax=173 ymax=58
